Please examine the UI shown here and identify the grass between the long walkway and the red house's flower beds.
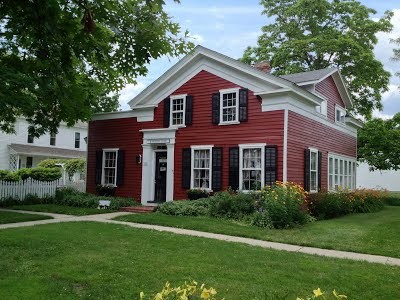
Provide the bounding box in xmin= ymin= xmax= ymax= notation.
xmin=116 ymin=206 xmax=400 ymax=257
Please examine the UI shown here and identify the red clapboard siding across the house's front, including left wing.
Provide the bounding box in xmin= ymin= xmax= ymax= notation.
xmin=87 ymin=71 xmax=284 ymax=200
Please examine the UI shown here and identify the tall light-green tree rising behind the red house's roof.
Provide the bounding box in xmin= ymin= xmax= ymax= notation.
xmin=242 ymin=0 xmax=393 ymax=118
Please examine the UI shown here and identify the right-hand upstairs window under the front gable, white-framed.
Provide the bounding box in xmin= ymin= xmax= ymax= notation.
xmin=219 ymin=88 xmax=239 ymax=124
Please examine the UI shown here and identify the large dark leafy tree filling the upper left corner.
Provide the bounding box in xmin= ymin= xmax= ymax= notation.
xmin=0 ymin=0 xmax=193 ymax=135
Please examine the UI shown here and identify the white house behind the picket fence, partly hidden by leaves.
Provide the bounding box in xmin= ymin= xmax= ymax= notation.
xmin=0 ymin=118 xmax=87 ymax=171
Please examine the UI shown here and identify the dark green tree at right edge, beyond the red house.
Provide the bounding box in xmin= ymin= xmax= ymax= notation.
xmin=358 ymin=113 xmax=400 ymax=170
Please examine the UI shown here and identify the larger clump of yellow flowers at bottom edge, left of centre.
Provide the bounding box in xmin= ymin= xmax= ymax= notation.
xmin=140 ymin=281 xmax=222 ymax=300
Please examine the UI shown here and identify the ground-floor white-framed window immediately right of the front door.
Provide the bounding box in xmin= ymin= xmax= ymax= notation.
xmin=190 ymin=145 xmax=213 ymax=190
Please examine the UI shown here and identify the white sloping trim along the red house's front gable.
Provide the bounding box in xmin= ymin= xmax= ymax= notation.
xmin=128 ymin=45 xmax=323 ymax=109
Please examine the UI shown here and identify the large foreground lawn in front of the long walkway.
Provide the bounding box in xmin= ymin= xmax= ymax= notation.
xmin=0 ymin=222 xmax=400 ymax=300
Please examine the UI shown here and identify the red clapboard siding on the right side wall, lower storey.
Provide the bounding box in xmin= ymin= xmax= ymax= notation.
xmin=287 ymin=111 xmax=357 ymax=189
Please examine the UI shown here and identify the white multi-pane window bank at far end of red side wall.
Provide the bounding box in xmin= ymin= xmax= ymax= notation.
xmin=328 ymin=154 xmax=356 ymax=191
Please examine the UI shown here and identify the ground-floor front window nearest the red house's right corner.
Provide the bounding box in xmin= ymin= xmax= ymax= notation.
xmin=239 ymin=144 xmax=266 ymax=191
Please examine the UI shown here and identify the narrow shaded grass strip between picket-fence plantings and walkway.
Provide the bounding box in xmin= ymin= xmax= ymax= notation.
xmin=8 ymin=204 xmax=114 ymax=216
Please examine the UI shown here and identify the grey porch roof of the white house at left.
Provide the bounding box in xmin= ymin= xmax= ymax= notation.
xmin=8 ymin=144 xmax=86 ymax=158
